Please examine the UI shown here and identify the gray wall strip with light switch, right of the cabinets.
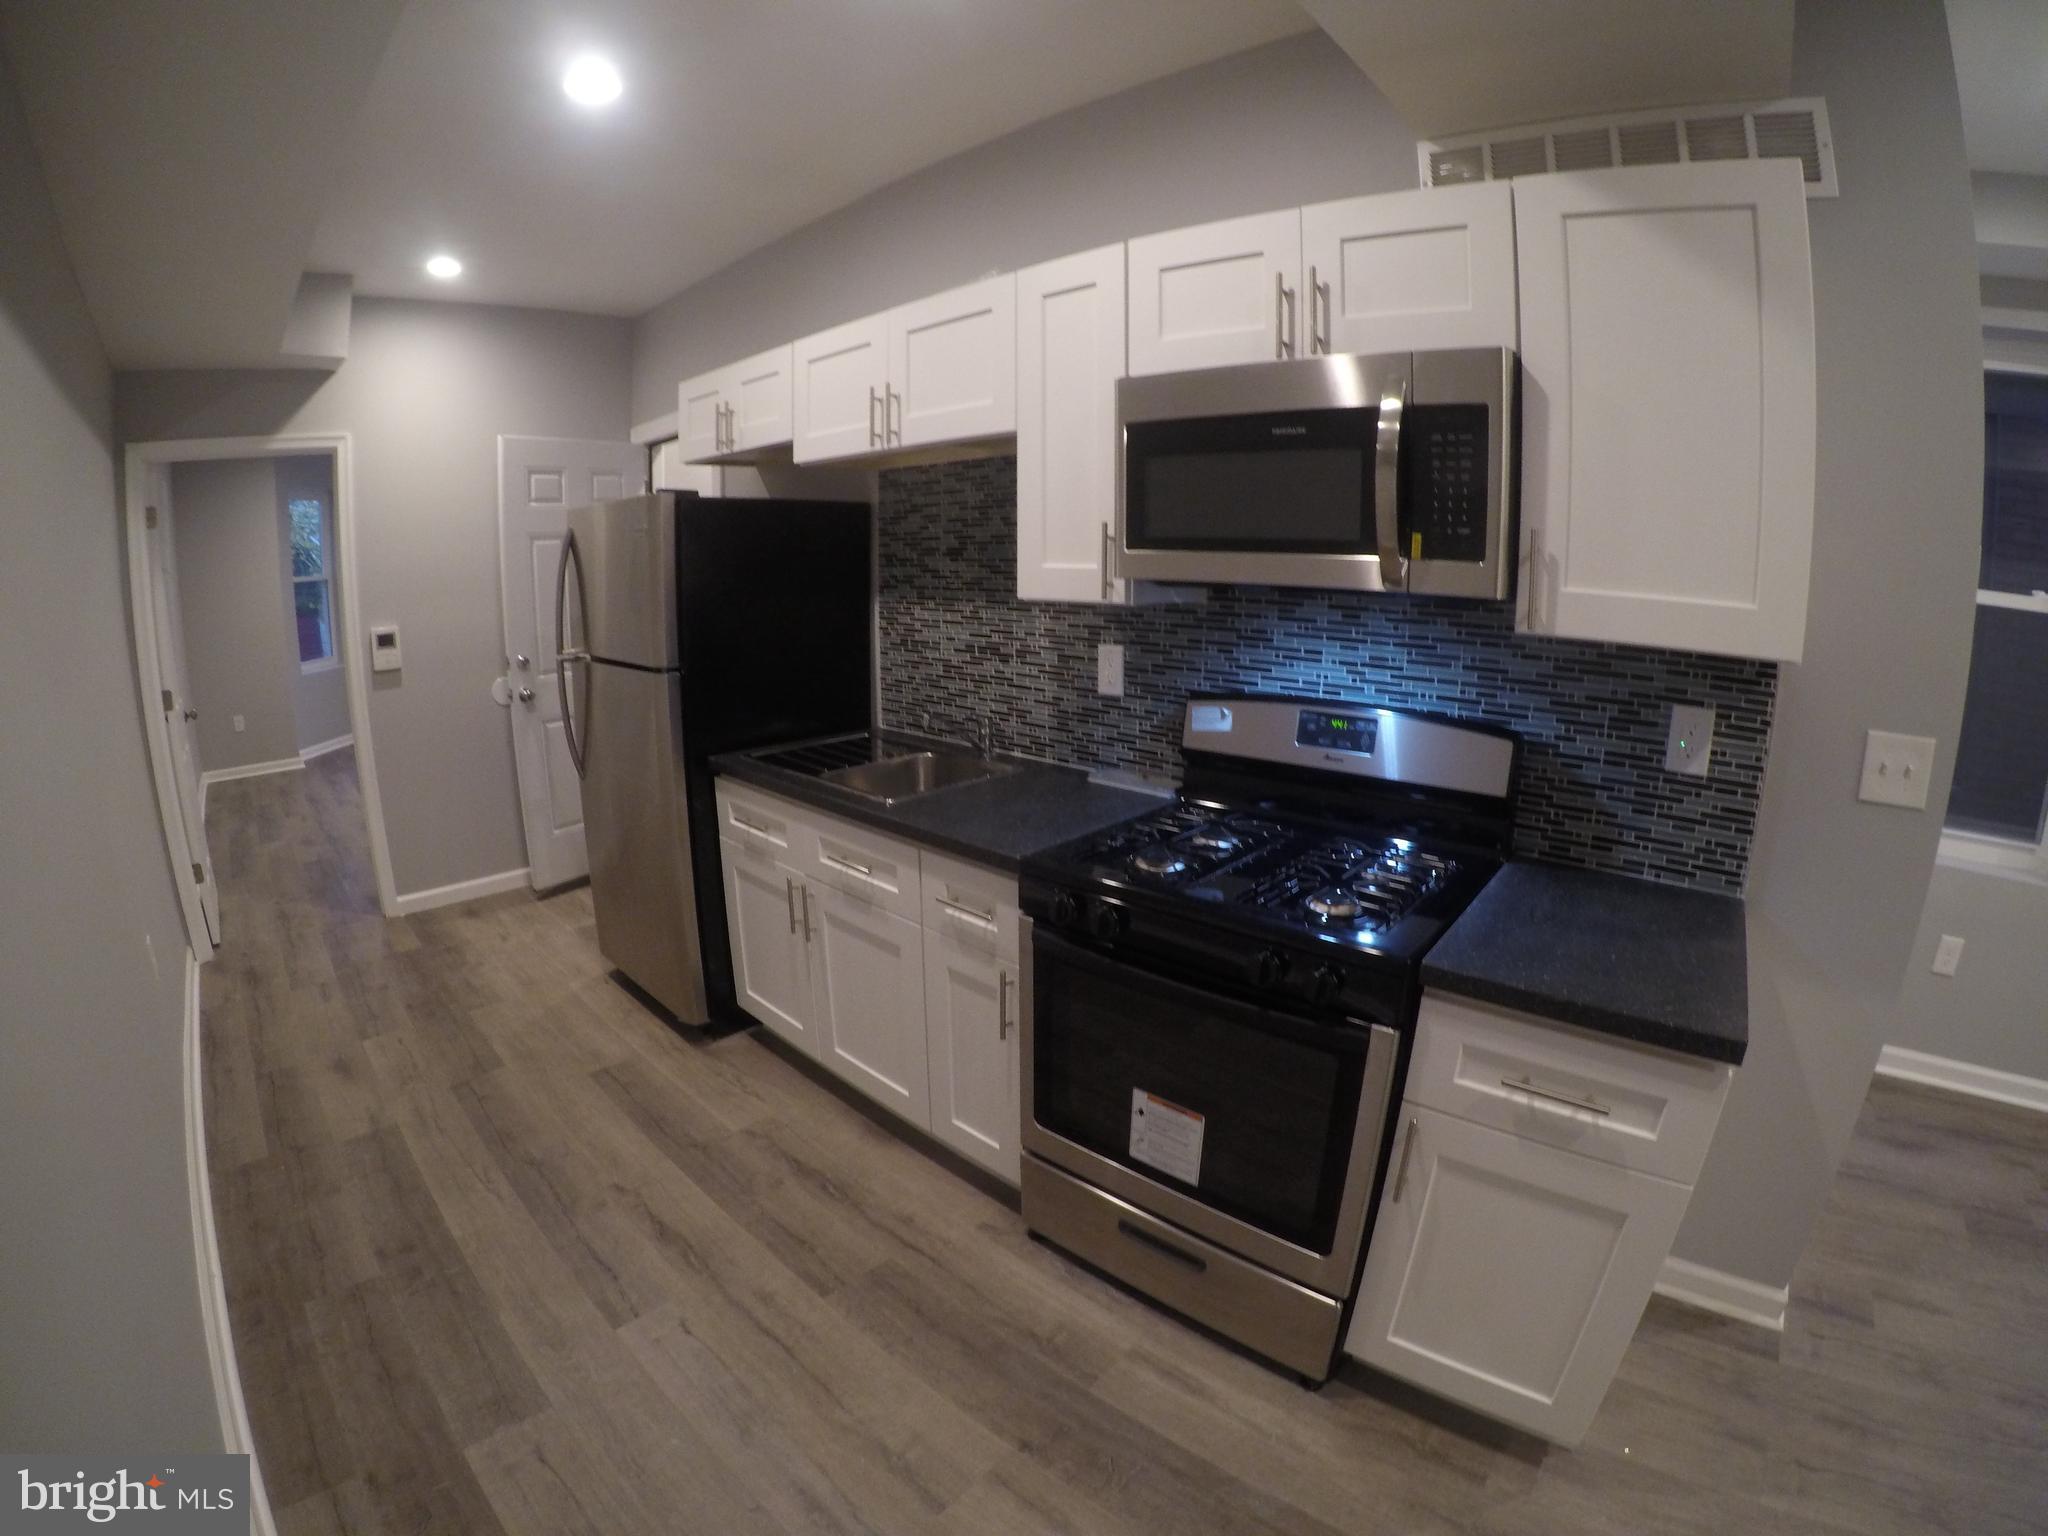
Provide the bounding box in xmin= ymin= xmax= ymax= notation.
xmin=1677 ymin=0 xmax=1982 ymax=1284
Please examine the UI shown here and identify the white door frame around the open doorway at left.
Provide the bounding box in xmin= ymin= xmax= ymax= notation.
xmin=123 ymin=432 xmax=397 ymax=961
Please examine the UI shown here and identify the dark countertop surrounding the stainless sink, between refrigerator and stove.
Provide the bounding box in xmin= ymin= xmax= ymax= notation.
xmin=711 ymin=733 xmax=1159 ymax=874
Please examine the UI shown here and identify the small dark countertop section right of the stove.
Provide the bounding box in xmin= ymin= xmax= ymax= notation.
xmin=1421 ymin=862 xmax=1749 ymax=1065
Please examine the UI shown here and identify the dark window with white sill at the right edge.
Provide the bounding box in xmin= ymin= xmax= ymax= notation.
xmin=1942 ymin=373 xmax=2048 ymax=874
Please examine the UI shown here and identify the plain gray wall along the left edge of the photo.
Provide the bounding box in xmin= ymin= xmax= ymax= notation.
xmin=0 ymin=48 xmax=221 ymax=1452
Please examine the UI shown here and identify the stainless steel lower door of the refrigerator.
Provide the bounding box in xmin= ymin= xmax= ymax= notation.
xmin=580 ymin=662 xmax=715 ymax=1024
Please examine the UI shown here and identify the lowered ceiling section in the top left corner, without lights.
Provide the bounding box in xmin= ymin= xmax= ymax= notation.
xmin=0 ymin=0 xmax=403 ymax=369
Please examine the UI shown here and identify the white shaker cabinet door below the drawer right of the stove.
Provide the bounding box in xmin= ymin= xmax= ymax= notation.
xmin=1343 ymin=1106 xmax=1692 ymax=1446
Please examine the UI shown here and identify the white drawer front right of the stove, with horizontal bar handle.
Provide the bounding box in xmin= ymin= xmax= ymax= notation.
xmin=1405 ymin=993 xmax=1735 ymax=1186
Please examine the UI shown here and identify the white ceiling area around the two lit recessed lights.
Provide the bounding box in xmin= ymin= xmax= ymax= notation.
xmin=305 ymin=0 xmax=1313 ymax=315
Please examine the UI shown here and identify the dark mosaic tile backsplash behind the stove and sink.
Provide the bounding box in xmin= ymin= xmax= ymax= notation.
xmin=879 ymin=459 xmax=1778 ymax=893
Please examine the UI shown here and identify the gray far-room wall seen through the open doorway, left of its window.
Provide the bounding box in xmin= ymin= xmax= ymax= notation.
xmin=170 ymin=459 xmax=299 ymax=774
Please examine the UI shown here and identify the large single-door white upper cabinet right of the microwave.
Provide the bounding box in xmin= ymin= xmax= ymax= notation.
xmin=1515 ymin=160 xmax=1815 ymax=662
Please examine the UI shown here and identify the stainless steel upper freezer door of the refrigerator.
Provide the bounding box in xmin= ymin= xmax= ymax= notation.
xmin=563 ymin=492 xmax=676 ymax=668
